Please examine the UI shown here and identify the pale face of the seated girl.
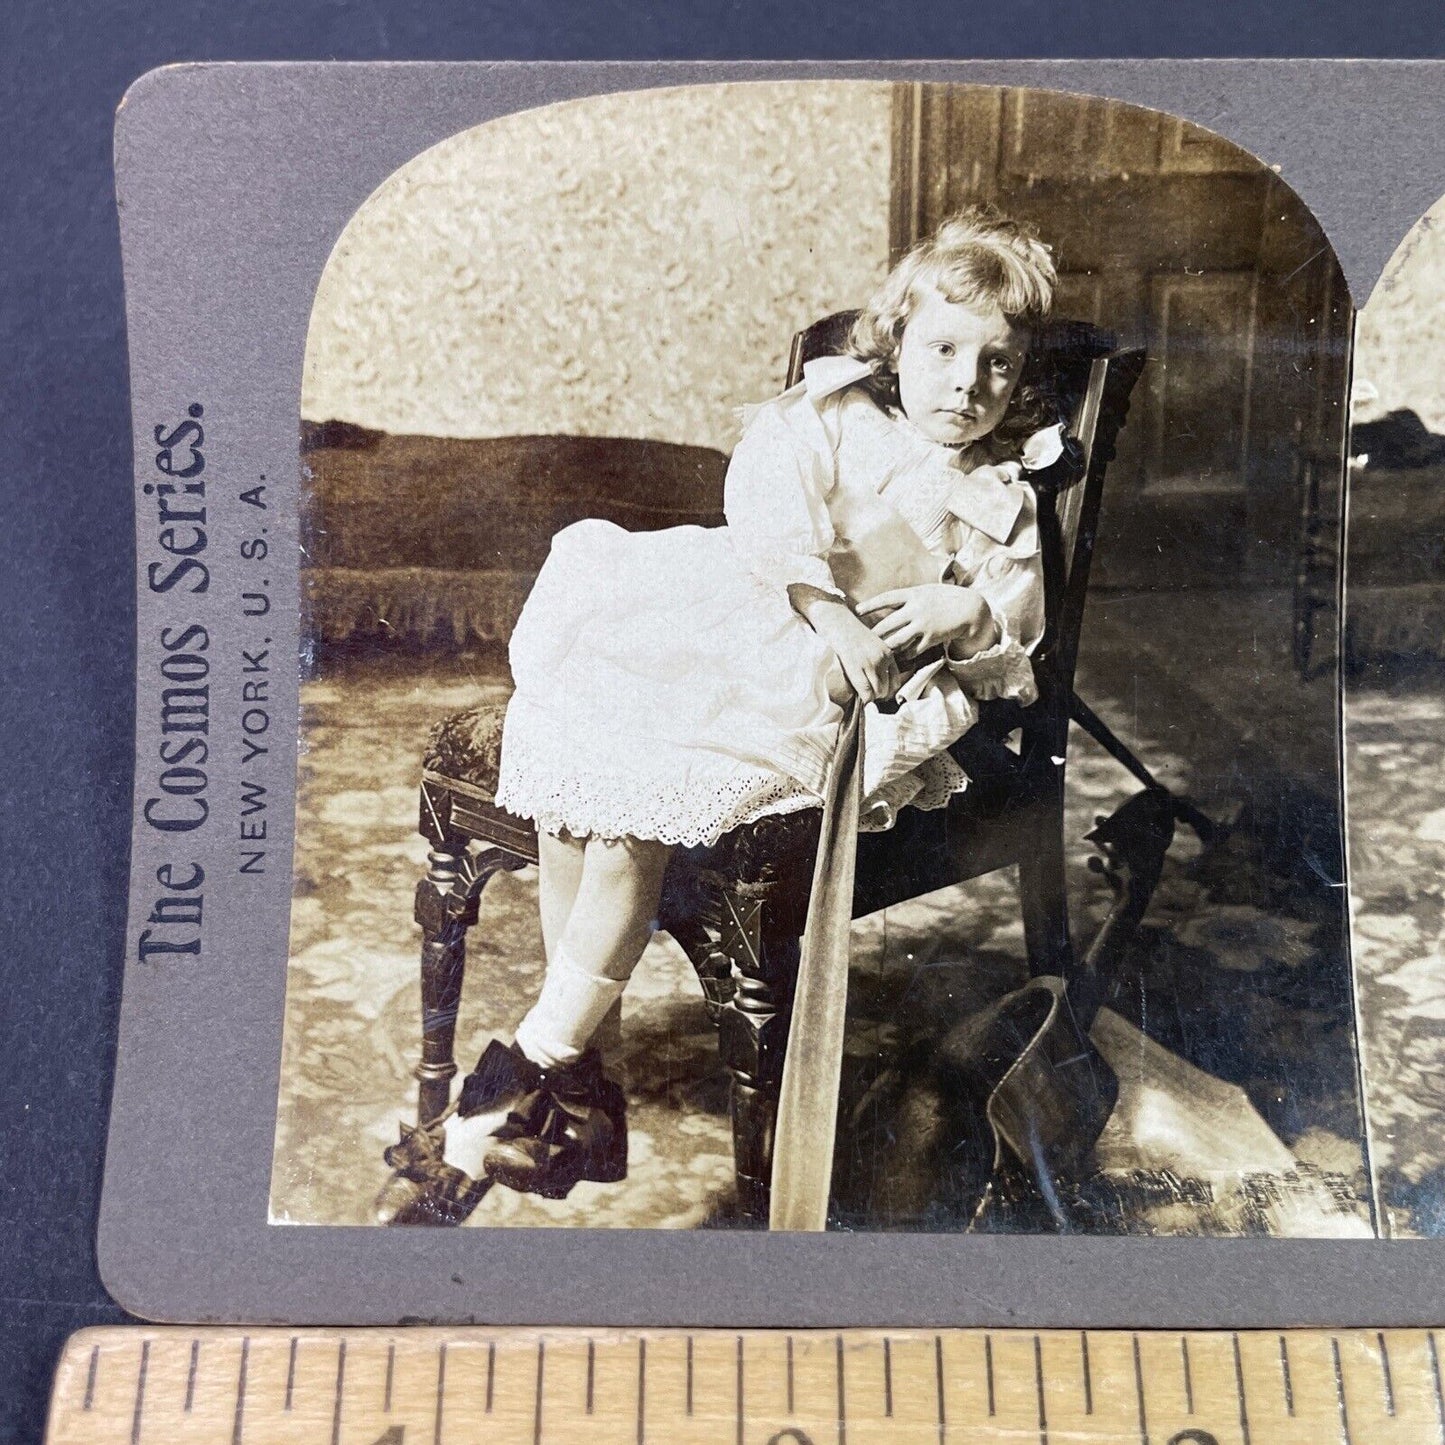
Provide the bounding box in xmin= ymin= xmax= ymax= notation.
xmin=897 ymin=286 xmax=1029 ymax=447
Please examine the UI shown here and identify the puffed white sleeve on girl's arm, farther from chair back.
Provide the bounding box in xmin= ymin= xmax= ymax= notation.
xmin=723 ymin=393 xmax=844 ymax=597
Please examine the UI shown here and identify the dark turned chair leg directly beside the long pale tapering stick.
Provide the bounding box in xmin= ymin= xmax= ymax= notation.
xmin=718 ymin=890 xmax=798 ymax=1225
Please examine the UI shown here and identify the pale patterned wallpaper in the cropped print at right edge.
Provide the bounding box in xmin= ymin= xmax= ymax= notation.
xmin=1355 ymin=197 xmax=1445 ymax=432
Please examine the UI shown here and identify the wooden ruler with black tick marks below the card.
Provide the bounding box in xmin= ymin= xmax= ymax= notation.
xmin=46 ymin=1325 xmax=1445 ymax=1445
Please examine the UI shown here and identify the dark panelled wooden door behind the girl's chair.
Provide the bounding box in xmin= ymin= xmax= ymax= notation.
xmin=892 ymin=85 xmax=1351 ymax=587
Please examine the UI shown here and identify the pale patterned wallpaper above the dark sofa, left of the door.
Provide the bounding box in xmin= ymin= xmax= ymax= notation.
xmin=301 ymin=81 xmax=890 ymax=451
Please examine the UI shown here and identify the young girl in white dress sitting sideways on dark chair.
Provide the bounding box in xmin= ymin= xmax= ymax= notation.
xmin=393 ymin=210 xmax=1062 ymax=1215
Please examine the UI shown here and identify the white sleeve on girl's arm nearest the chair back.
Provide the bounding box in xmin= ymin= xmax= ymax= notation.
xmin=948 ymin=483 xmax=1043 ymax=705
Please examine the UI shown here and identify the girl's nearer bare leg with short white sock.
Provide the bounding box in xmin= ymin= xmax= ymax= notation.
xmin=516 ymin=838 xmax=672 ymax=1068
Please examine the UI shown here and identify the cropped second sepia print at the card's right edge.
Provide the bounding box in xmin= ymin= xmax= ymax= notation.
xmin=1340 ymin=199 xmax=1445 ymax=1238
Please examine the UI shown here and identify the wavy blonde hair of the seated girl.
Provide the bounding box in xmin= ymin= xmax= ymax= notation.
xmin=845 ymin=205 xmax=1058 ymax=441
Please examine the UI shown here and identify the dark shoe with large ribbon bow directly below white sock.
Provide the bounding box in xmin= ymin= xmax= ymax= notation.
xmin=484 ymin=1046 xmax=627 ymax=1199
